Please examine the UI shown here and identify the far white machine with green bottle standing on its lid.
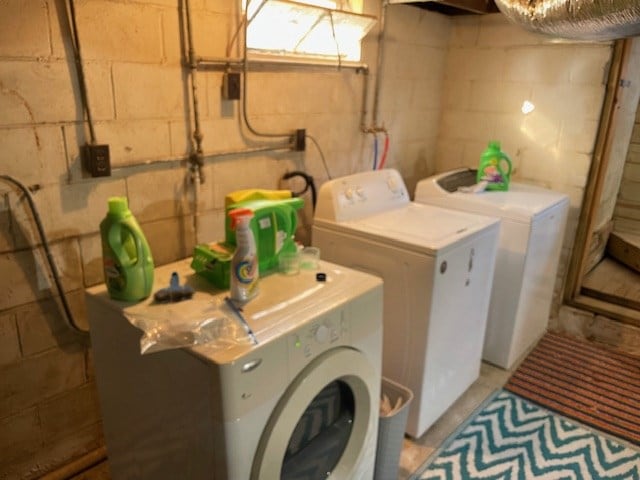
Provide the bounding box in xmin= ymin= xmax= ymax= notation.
xmin=415 ymin=169 xmax=569 ymax=369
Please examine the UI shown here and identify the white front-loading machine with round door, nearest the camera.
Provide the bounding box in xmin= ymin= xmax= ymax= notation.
xmin=86 ymin=260 xmax=382 ymax=480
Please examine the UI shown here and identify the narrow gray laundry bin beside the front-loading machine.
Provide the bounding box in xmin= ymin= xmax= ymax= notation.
xmin=373 ymin=377 xmax=413 ymax=480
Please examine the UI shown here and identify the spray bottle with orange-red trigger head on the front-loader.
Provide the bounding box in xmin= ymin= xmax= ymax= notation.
xmin=229 ymin=208 xmax=259 ymax=303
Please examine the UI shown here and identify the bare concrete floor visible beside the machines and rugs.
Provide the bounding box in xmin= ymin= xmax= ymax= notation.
xmin=75 ymin=363 xmax=511 ymax=480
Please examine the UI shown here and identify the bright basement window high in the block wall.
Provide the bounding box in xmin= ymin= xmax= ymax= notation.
xmin=246 ymin=0 xmax=376 ymax=62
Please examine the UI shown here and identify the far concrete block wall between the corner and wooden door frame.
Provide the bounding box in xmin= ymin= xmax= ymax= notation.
xmin=435 ymin=14 xmax=612 ymax=315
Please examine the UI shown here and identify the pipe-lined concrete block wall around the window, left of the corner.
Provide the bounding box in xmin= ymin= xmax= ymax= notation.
xmin=0 ymin=0 xmax=450 ymax=480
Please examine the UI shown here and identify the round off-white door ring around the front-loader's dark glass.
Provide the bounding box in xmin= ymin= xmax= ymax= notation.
xmin=251 ymin=347 xmax=381 ymax=480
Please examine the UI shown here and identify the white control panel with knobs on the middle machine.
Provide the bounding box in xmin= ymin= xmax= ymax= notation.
xmin=316 ymin=169 xmax=410 ymax=222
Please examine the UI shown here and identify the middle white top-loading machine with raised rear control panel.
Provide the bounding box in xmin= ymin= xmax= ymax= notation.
xmin=312 ymin=169 xmax=499 ymax=437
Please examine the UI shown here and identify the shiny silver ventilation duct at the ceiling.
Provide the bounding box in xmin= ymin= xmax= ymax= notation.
xmin=495 ymin=0 xmax=640 ymax=41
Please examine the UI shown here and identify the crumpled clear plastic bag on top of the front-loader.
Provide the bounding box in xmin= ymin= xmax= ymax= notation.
xmin=125 ymin=304 xmax=252 ymax=354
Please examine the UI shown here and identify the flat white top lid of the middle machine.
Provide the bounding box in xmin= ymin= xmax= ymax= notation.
xmin=335 ymin=202 xmax=499 ymax=256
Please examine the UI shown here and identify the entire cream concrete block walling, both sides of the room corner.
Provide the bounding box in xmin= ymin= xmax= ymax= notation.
xmin=0 ymin=0 xmax=624 ymax=479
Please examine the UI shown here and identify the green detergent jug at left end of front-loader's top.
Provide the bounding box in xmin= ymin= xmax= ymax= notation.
xmin=100 ymin=197 xmax=153 ymax=302
